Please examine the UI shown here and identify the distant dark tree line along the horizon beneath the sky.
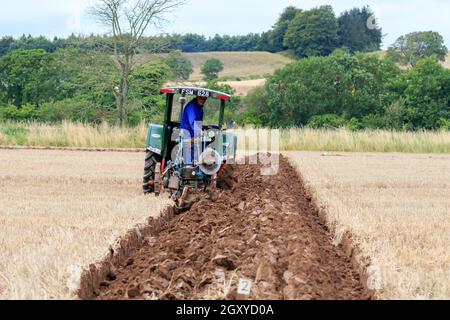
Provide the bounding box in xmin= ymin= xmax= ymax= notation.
xmin=0 ymin=6 xmax=382 ymax=57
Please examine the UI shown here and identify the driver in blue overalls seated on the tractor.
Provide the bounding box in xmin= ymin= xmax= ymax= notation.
xmin=181 ymin=96 xmax=208 ymax=163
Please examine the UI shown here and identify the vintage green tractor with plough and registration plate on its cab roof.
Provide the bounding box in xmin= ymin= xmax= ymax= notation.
xmin=142 ymin=87 xmax=237 ymax=211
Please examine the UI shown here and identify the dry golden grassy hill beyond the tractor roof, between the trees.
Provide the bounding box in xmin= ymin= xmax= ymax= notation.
xmin=138 ymin=52 xmax=293 ymax=81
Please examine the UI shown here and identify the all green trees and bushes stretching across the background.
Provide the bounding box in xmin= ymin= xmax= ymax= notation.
xmin=0 ymin=0 xmax=450 ymax=130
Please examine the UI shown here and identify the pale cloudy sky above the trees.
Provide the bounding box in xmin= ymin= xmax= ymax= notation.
xmin=0 ymin=0 xmax=450 ymax=48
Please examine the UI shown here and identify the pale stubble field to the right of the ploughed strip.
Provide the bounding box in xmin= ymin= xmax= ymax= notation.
xmin=288 ymin=152 xmax=450 ymax=299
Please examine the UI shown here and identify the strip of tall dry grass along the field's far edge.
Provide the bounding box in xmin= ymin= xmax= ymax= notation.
xmin=0 ymin=122 xmax=450 ymax=153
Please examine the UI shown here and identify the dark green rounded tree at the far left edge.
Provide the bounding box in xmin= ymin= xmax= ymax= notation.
xmin=0 ymin=49 xmax=59 ymax=107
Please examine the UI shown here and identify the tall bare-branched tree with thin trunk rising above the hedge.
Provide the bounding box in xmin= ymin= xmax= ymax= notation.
xmin=90 ymin=0 xmax=184 ymax=126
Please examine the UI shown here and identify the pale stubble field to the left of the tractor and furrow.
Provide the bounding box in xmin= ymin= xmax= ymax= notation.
xmin=0 ymin=150 xmax=167 ymax=299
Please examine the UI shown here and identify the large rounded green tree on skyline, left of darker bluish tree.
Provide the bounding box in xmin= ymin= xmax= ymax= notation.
xmin=284 ymin=5 xmax=338 ymax=57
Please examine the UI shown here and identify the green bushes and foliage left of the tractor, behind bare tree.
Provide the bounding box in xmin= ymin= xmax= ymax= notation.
xmin=0 ymin=48 xmax=173 ymax=125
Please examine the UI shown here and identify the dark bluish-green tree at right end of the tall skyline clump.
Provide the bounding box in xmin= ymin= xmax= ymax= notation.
xmin=338 ymin=7 xmax=383 ymax=52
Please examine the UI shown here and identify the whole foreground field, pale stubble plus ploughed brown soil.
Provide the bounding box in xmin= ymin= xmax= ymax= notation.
xmin=0 ymin=150 xmax=450 ymax=299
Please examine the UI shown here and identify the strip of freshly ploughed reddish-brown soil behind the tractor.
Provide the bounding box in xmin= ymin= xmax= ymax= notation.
xmin=97 ymin=157 xmax=372 ymax=300
